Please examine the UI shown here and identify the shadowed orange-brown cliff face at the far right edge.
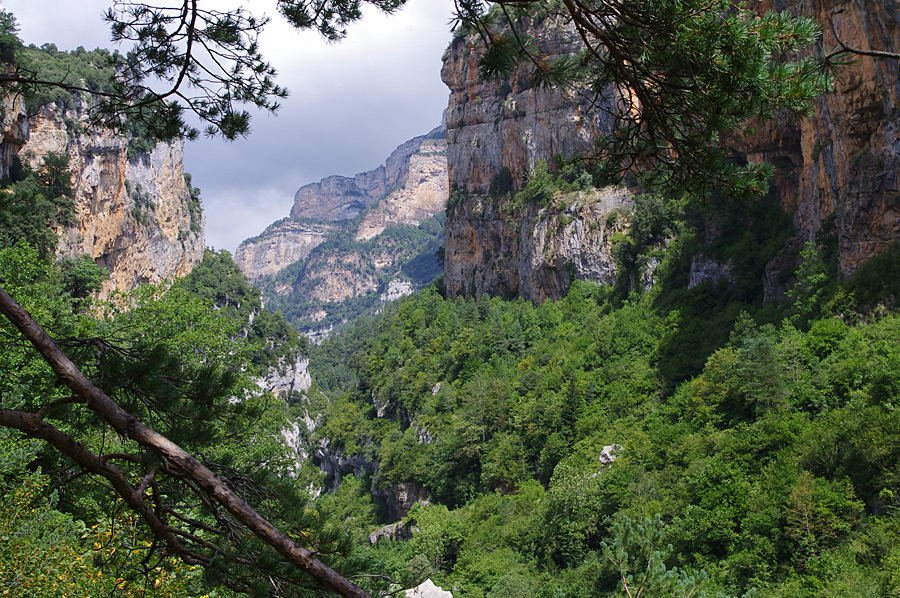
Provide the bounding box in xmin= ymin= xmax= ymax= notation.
xmin=736 ymin=0 xmax=900 ymax=276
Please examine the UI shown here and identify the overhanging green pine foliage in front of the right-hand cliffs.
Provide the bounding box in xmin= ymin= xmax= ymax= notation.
xmin=456 ymin=0 xmax=836 ymax=196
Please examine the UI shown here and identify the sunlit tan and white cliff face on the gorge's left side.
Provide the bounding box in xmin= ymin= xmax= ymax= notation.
xmin=15 ymin=105 xmax=205 ymax=298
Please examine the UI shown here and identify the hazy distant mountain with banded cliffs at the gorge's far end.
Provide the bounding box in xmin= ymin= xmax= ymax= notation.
xmin=235 ymin=129 xmax=449 ymax=336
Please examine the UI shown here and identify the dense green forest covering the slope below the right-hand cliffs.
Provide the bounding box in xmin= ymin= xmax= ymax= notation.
xmin=300 ymin=266 xmax=900 ymax=597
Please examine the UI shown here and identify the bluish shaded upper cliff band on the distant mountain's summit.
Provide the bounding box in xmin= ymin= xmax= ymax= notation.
xmin=291 ymin=128 xmax=443 ymax=221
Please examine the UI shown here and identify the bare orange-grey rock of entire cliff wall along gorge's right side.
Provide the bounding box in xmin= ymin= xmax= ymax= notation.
xmin=442 ymin=0 xmax=900 ymax=301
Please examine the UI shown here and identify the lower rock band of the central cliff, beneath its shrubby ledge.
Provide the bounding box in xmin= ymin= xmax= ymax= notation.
xmin=444 ymin=187 xmax=631 ymax=302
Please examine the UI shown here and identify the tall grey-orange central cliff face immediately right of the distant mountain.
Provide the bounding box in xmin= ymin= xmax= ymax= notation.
xmin=441 ymin=19 xmax=631 ymax=302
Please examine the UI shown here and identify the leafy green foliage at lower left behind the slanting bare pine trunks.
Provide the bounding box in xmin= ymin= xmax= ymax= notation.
xmin=0 ymin=244 xmax=298 ymax=596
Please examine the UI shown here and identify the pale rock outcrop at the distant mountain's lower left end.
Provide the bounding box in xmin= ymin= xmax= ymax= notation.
xmin=234 ymin=219 xmax=335 ymax=282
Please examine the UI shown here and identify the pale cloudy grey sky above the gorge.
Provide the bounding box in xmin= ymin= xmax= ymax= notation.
xmin=0 ymin=0 xmax=452 ymax=252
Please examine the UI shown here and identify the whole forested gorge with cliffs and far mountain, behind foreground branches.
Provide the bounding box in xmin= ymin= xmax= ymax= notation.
xmin=0 ymin=0 xmax=900 ymax=598
